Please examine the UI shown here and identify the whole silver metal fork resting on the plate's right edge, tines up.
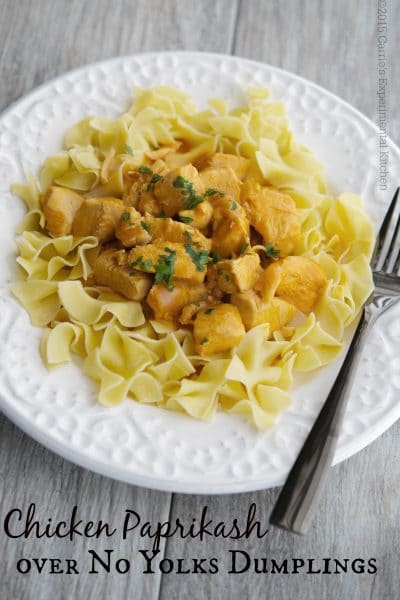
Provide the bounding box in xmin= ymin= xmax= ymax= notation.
xmin=270 ymin=188 xmax=400 ymax=533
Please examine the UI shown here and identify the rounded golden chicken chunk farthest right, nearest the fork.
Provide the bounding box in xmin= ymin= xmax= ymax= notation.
xmin=266 ymin=256 xmax=327 ymax=315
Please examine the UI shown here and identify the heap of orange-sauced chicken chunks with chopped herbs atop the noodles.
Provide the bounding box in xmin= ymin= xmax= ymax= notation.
xmin=42 ymin=149 xmax=327 ymax=357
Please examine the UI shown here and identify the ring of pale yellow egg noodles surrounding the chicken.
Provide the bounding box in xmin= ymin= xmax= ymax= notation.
xmin=12 ymin=87 xmax=373 ymax=429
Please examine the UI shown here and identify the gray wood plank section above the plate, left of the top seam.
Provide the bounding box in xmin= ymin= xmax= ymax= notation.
xmin=0 ymin=0 xmax=238 ymax=110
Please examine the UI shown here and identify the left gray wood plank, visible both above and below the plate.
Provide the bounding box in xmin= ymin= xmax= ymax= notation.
xmin=0 ymin=0 xmax=238 ymax=600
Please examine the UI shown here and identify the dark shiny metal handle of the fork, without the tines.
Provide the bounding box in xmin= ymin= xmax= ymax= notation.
xmin=270 ymin=309 xmax=370 ymax=533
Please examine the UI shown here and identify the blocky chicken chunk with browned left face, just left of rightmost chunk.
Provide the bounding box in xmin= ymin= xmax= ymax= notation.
xmin=207 ymin=253 xmax=261 ymax=294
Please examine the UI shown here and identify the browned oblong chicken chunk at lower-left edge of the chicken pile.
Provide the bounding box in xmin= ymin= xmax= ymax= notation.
xmin=93 ymin=249 xmax=153 ymax=300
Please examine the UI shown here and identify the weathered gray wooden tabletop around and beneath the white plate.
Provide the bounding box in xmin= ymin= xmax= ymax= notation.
xmin=0 ymin=0 xmax=400 ymax=600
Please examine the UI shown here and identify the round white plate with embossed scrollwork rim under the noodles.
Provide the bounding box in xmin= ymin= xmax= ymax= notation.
xmin=0 ymin=52 xmax=400 ymax=493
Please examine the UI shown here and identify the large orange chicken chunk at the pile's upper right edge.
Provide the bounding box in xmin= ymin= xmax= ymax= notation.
xmin=241 ymin=180 xmax=300 ymax=256
